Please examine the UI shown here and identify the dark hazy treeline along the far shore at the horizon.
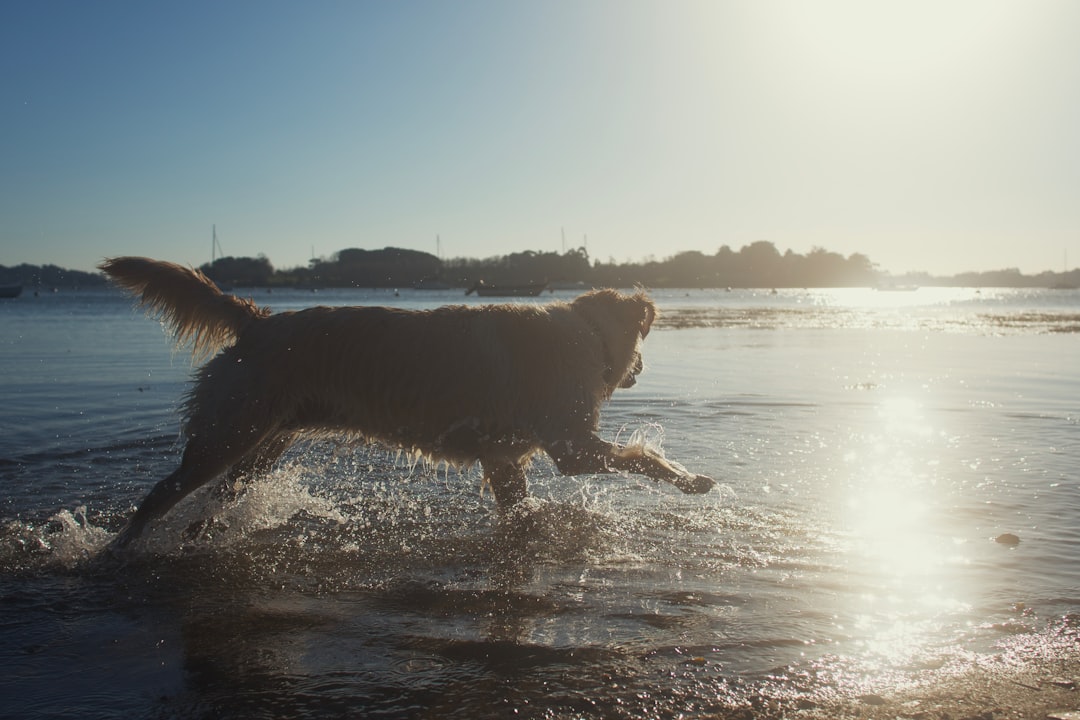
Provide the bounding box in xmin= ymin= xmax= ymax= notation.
xmin=0 ymin=241 xmax=1080 ymax=288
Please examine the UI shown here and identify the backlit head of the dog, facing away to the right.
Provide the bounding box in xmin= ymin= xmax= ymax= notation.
xmin=572 ymin=289 xmax=657 ymax=394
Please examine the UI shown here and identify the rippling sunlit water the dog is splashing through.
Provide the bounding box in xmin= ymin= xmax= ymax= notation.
xmin=0 ymin=288 xmax=1080 ymax=718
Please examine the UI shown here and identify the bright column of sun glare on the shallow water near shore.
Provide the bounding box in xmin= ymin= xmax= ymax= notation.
xmin=841 ymin=395 xmax=962 ymax=663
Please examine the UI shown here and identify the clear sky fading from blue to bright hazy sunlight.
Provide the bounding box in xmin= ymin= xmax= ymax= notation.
xmin=0 ymin=0 xmax=1080 ymax=274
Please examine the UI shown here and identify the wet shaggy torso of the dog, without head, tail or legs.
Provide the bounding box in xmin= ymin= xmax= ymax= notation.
xmin=188 ymin=303 xmax=605 ymax=463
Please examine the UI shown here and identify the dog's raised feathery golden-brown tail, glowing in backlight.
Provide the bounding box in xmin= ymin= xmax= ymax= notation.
xmin=98 ymin=257 xmax=270 ymax=361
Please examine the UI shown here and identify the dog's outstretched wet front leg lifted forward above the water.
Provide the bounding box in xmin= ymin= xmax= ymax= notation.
xmin=544 ymin=435 xmax=715 ymax=494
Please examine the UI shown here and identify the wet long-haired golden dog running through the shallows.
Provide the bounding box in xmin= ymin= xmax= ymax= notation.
xmin=98 ymin=257 xmax=714 ymax=549
